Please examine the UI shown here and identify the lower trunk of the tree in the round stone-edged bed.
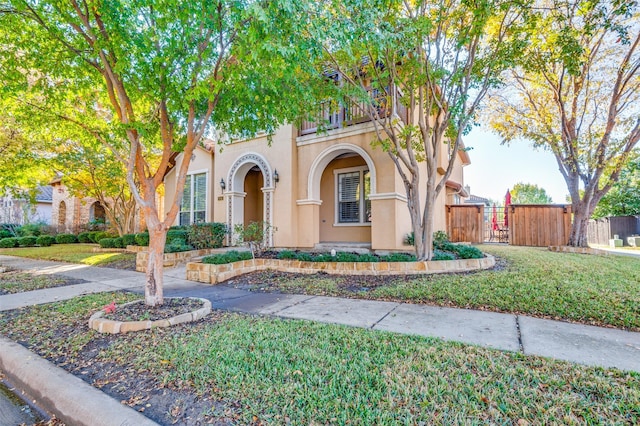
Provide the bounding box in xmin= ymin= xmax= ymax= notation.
xmin=144 ymin=223 xmax=167 ymax=306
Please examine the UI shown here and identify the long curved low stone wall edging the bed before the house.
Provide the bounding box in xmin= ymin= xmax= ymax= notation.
xmin=187 ymin=255 xmax=496 ymax=284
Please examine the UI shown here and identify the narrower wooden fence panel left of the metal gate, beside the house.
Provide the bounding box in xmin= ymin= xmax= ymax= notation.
xmin=447 ymin=204 xmax=484 ymax=243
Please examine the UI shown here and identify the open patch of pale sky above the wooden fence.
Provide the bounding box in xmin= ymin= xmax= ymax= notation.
xmin=464 ymin=128 xmax=569 ymax=204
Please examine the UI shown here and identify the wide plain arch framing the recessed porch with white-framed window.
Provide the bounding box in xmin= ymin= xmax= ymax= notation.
xmin=308 ymin=144 xmax=376 ymax=244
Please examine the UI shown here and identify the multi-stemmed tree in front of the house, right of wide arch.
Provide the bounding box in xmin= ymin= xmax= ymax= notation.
xmin=311 ymin=0 xmax=526 ymax=259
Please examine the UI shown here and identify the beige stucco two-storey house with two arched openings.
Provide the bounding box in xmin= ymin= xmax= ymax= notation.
xmin=165 ymin=101 xmax=469 ymax=250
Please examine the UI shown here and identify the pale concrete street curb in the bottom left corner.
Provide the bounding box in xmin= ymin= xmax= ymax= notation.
xmin=0 ymin=336 xmax=157 ymax=426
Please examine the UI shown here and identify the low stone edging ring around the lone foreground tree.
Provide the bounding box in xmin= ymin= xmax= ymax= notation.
xmin=89 ymin=297 xmax=211 ymax=334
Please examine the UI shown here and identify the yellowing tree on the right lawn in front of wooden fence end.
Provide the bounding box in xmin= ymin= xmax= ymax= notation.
xmin=490 ymin=0 xmax=640 ymax=246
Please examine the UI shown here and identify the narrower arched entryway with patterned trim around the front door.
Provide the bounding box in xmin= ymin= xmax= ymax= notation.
xmin=225 ymin=153 xmax=275 ymax=246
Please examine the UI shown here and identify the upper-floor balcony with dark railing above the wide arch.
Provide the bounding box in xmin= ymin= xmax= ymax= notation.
xmin=298 ymin=88 xmax=407 ymax=136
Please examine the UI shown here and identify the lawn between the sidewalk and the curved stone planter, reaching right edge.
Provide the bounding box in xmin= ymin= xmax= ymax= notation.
xmin=258 ymin=245 xmax=640 ymax=330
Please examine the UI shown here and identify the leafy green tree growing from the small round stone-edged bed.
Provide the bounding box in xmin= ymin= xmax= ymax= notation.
xmin=0 ymin=0 xmax=312 ymax=306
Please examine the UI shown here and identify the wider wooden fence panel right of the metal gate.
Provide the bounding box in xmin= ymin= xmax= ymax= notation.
xmin=508 ymin=204 xmax=571 ymax=247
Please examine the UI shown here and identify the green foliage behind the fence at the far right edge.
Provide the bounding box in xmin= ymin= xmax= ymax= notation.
xmin=592 ymin=155 xmax=640 ymax=219
